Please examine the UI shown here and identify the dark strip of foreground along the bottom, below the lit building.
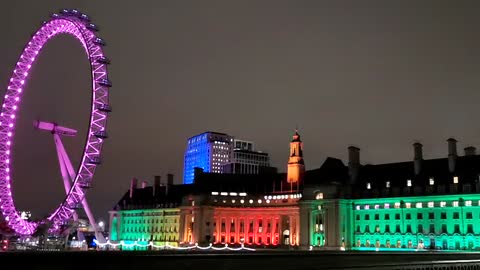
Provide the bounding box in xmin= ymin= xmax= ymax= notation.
xmin=0 ymin=251 xmax=480 ymax=270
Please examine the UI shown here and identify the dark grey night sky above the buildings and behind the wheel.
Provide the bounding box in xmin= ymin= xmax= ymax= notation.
xmin=0 ymin=0 xmax=480 ymax=224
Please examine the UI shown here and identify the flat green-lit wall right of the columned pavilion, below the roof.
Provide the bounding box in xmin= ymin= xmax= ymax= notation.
xmin=351 ymin=194 xmax=480 ymax=250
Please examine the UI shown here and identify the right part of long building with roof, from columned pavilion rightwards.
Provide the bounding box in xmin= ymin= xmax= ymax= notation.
xmin=300 ymin=139 xmax=480 ymax=251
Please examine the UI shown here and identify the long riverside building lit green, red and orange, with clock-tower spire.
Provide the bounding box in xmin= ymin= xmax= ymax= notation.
xmin=110 ymin=133 xmax=480 ymax=251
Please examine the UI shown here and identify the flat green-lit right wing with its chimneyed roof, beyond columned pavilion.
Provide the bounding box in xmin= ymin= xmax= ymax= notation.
xmin=344 ymin=138 xmax=480 ymax=250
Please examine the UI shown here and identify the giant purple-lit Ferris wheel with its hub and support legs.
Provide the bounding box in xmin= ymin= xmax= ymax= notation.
xmin=0 ymin=9 xmax=112 ymax=240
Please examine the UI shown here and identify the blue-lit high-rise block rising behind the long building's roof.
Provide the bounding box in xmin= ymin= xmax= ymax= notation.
xmin=183 ymin=131 xmax=233 ymax=184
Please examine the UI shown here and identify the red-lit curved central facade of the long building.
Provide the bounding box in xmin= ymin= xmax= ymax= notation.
xmin=180 ymin=199 xmax=300 ymax=246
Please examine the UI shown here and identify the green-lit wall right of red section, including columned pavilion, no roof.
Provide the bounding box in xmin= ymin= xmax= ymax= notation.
xmin=300 ymin=186 xmax=480 ymax=251
